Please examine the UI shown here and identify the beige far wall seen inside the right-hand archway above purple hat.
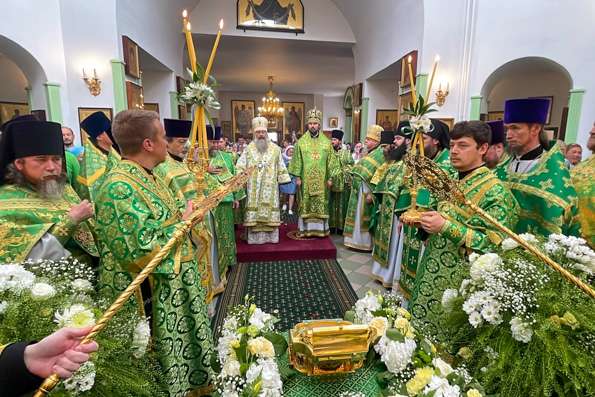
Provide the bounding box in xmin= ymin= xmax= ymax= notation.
xmin=487 ymin=72 xmax=570 ymax=127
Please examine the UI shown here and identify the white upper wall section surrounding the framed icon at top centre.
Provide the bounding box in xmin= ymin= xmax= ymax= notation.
xmin=193 ymin=0 xmax=355 ymax=43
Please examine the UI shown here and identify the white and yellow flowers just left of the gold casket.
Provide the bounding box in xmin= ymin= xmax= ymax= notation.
xmin=215 ymin=296 xmax=287 ymax=397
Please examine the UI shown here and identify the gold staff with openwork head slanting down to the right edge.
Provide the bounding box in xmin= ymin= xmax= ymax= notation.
xmin=404 ymin=155 xmax=595 ymax=299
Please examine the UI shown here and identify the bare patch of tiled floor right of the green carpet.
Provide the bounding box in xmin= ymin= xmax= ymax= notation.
xmin=331 ymin=235 xmax=384 ymax=298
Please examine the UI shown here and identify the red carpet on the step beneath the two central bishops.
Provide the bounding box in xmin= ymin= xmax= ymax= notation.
xmin=236 ymin=224 xmax=337 ymax=262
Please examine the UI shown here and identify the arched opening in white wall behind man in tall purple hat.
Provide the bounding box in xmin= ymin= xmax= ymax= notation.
xmin=481 ymin=57 xmax=572 ymax=139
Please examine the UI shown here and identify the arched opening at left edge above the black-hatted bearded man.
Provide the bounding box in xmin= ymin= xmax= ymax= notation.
xmin=0 ymin=36 xmax=47 ymax=122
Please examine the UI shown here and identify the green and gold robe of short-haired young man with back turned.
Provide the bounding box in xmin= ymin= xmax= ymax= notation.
xmin=95 ymin=160 xmax=213 ymax=397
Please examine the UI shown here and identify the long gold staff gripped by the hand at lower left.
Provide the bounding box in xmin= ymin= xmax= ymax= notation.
xmin=33 ymin=167 xmax=254 ymax=397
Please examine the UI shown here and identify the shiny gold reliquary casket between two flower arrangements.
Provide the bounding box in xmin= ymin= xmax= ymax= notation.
xmin=289 ymin=320 xmax=379 ymax=376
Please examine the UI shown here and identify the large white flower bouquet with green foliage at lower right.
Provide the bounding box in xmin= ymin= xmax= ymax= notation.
xmin=442 ymin=233 xmax=595 ymax=397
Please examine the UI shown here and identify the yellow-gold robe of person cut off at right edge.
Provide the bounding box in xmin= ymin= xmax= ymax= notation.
xmin=570 ymin=154 xmax=595 ymax=249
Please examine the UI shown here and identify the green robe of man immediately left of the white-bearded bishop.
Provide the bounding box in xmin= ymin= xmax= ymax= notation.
xmin=207 ymin=150 xmax=246 ymax=279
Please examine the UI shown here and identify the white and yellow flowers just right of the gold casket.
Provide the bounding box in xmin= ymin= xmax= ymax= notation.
xmin=345 ymin=291 xmax=485 ymax=397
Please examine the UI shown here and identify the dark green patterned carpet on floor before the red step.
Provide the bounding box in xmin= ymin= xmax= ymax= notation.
xmin=213 ymin=259 xmax=357 ymax=340
